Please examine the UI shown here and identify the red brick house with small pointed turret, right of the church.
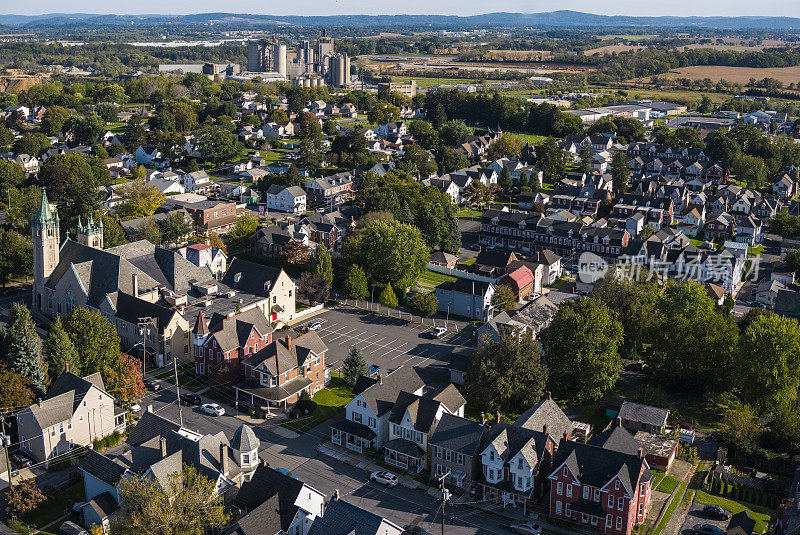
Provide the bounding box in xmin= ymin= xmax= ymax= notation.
xmin=192 ymin=308 xmax=272 ymax=378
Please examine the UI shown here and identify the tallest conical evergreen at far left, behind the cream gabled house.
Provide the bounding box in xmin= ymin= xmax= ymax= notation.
xmin=8 ymin=303 xmax=46 ymax=396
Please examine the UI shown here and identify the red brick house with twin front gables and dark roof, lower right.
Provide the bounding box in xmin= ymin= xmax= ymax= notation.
xmin=550 ymin=436 xmax=653 ymax=535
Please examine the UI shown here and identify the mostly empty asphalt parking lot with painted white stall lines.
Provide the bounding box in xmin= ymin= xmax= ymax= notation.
xmin=314 ymin=308 xmax=474 ymax=373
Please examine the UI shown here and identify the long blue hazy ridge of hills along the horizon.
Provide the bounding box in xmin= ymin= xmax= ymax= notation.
xmin=0 ymin=10 xmax=800 ymax=30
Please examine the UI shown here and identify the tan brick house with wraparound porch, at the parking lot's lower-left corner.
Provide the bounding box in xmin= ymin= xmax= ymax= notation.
xmin=233 ymin=331 xmax=328 ymax=411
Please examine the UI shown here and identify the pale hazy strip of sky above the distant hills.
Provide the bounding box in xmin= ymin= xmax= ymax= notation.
xmin=0 ymin=0 xmax=800 ymax=17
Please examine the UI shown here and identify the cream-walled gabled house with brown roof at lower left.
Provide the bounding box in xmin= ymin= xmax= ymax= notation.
xmin=16 ymin=371 xmax=126 ymax=463
